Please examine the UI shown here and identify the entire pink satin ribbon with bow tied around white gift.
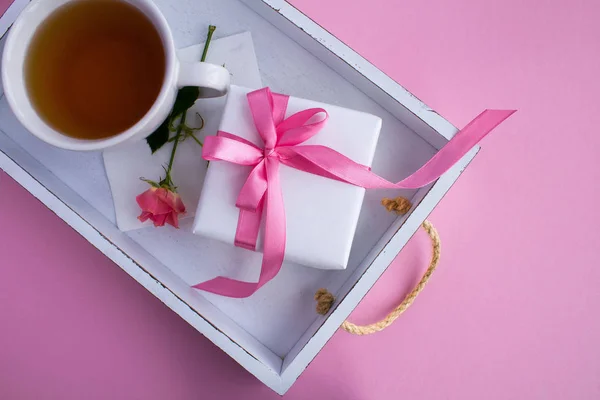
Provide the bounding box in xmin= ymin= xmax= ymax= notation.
xmin=194 ymin=88 xmax=515 ymax=298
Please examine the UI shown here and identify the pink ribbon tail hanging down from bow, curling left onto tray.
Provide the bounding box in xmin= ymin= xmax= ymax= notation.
xmin=193 ymin=159 xmax=286 ymax=299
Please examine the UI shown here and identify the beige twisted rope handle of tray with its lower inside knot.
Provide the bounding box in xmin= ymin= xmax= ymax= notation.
xmin=315 ymin=217 xmax=440 ymax=336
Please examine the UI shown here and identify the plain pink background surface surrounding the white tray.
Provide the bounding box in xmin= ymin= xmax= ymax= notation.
xmin=0 ymin=0 xmax=600 ymax=400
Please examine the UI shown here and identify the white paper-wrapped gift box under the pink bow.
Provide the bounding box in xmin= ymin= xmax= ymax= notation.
xmin=193 ymin=86 xmax=381 ymax=269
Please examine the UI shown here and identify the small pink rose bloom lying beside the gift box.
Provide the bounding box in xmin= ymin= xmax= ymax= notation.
xmin=135 ymin=187 xmax=185 ymax=228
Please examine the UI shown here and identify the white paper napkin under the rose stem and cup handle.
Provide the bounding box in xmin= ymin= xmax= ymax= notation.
xmin=103 ymin=32 xmax=262 ymax=231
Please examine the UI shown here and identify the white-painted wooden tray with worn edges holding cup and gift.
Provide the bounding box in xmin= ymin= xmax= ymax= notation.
xmin=0 ymin=0 xmax=478 ymax=394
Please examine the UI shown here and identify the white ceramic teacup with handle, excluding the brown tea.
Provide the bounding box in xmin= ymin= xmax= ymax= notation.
xmin=2 ymin=0 xmax=230 ymax=150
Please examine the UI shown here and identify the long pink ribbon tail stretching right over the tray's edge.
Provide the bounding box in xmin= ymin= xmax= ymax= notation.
xmin=282 ymin=110 xmax=515 ymax=189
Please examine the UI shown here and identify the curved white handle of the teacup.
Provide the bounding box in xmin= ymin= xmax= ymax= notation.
xmin=177 ymin=62 xmax=231 ymax=98
